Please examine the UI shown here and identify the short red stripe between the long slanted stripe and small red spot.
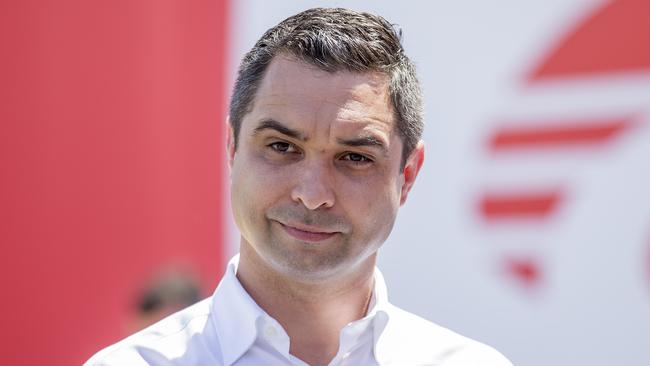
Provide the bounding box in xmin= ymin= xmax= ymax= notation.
xmin=480 ymin=191 xmax=562 ymax=219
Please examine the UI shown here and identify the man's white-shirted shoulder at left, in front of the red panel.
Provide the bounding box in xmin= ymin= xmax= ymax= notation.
xmin=84 ymin=298 xmax=219 ymax=366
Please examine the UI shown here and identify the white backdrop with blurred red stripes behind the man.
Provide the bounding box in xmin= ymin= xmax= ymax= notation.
xmin=225 ymin=0 xmax=650 ymax=366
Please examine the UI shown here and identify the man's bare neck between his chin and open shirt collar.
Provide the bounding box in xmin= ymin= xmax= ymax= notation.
xmin=237 ymin=243 xmax=376 ymax=366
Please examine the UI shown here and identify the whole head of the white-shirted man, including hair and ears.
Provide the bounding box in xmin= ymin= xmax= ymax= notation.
xmin=228 ymin=9 xmax=424 ymax=281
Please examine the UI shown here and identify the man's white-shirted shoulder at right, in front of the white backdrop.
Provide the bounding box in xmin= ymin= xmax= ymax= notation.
xmin=382 ymin=305 xmax=512 ymax=366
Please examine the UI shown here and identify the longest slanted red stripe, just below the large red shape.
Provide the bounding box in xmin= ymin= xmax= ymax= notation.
xmin=489 ymin=118 xmax=631 ymax=151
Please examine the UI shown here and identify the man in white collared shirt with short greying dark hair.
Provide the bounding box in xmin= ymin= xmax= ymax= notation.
xmin=87 ymin=9 xmax=510 ymax=366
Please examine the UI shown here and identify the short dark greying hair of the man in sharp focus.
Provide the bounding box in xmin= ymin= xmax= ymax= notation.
xmin=229 ymin=8 xmax=424 ymax=164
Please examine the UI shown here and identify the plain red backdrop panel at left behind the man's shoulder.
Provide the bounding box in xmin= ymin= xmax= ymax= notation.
xmin=0 ymin=0 xmax=228 ymax=365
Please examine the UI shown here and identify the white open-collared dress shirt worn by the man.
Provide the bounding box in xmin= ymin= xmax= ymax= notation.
xmin=84 ymin=255 xmax=512 ymax=366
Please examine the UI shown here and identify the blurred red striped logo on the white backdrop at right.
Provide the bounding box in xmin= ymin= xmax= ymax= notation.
xmin=476 ymin=0 xmax=650 ymax=288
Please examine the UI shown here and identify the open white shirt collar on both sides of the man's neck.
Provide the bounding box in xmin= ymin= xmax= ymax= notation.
xmin=211 ymin=254 xmax=390 ymax=365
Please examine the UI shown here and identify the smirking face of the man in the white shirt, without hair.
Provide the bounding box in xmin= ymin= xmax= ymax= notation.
xmin=229 ymin=56 xmax=422 ymax=281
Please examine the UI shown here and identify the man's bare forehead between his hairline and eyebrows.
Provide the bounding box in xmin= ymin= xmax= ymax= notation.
xmin=249 ymin=55 xmax=394 ymax=137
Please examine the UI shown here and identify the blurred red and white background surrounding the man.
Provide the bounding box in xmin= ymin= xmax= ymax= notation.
xmin=0 ymin=0 xmax=650 ymax=366
